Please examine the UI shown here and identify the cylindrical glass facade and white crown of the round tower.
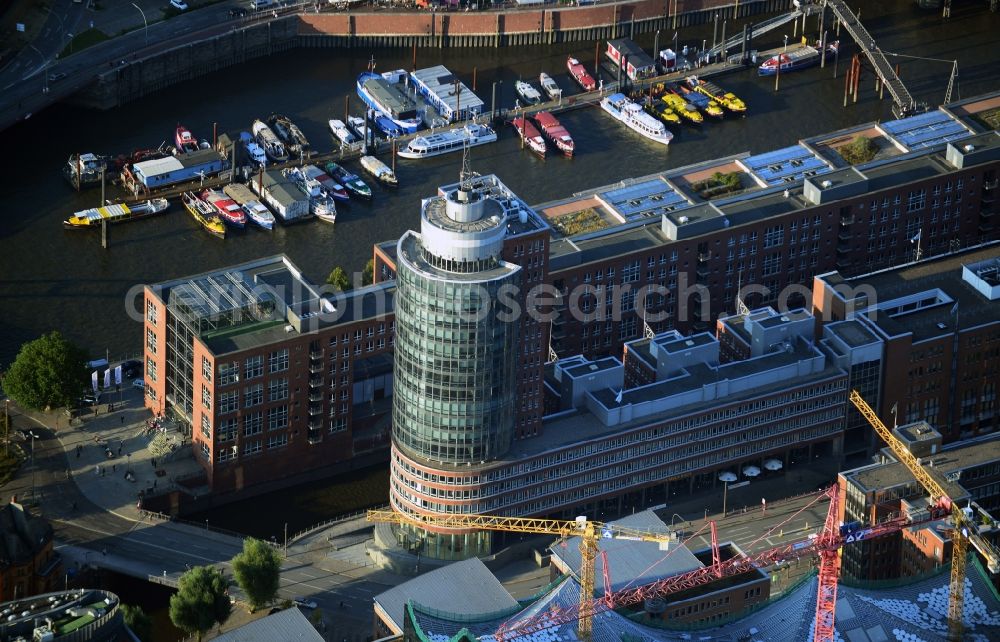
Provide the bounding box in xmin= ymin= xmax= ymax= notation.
xmin=390 ymin=182 xmax=523 ymax=560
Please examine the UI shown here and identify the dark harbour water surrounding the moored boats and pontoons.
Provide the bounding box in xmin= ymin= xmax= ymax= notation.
xmin=0 ymin=0 xmax=1000 ymax=370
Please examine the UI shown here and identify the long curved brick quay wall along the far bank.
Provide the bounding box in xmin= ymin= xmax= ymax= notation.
xmin=78 ymin=0 xmax=791 ymax=109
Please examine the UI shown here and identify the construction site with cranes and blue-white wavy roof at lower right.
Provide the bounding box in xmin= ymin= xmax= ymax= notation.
xmin=368 ymin=391 xmax=1000 ymax=642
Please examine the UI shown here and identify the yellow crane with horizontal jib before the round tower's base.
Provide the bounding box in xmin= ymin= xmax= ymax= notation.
xmin=368 ymin=510 xmax=680 ymax=640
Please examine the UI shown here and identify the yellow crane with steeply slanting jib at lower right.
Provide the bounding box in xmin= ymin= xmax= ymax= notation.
xmin=850 ymin=390 xmax=1000 ymax=641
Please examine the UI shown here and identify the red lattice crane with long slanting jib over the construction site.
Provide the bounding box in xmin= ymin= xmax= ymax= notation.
xmin=495 ymin=484 xmax=949 ymax=642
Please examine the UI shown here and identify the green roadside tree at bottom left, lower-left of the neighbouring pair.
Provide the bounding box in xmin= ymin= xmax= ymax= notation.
xmin=170 ymin=566 xmax=233 ymax=642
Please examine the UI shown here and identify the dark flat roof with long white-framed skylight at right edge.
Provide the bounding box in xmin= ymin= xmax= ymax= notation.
xmin=836 ymin=241 xmax=1000 ymax=343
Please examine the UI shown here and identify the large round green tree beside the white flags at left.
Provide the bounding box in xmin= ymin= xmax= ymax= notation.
xmin=3 ymin=331 xmax=87 ymax=410
